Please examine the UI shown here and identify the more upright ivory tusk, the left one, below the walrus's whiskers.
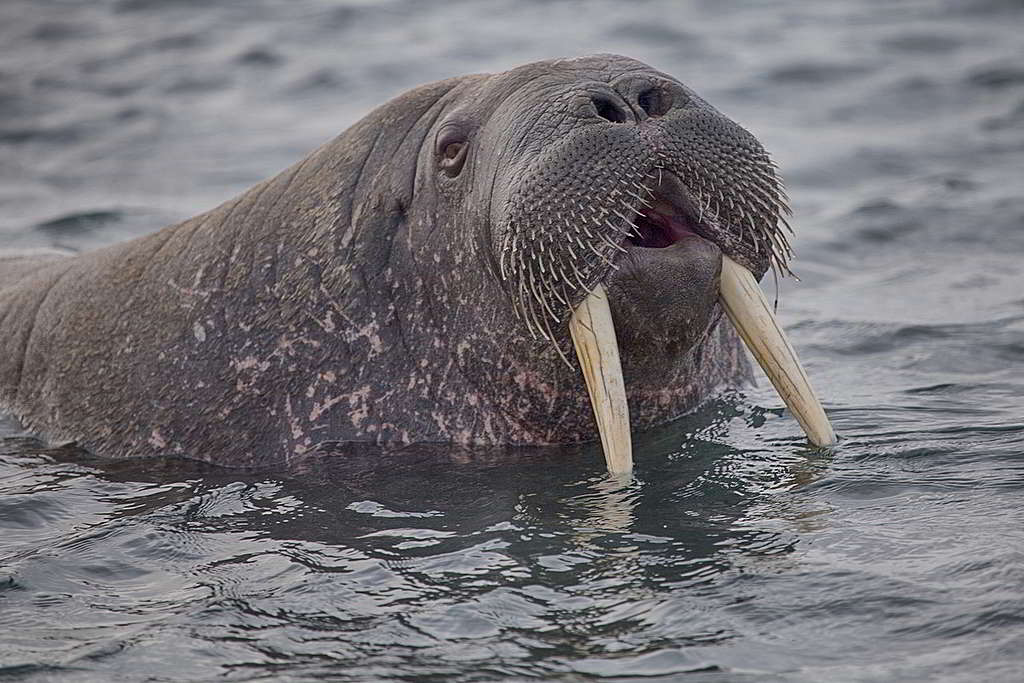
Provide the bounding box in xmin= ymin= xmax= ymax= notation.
xmin=569 ymin=285 xmax=633 ymax=474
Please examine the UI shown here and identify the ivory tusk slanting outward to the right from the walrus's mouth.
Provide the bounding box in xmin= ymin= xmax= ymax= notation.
xmin=721 ymin=255 xmax=836 ymax=446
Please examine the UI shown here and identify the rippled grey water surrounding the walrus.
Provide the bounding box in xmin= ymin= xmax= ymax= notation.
xmin=0 ymin=0 xmax=1024 ymax=681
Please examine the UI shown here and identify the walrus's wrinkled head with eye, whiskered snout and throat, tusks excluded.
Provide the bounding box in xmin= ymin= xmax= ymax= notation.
xmin=403 ymin=55 xmax=827 ymax=464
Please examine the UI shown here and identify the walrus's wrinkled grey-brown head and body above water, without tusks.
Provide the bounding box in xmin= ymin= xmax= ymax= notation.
xmin=0 ymin=55 xmax=787 ymax=465
